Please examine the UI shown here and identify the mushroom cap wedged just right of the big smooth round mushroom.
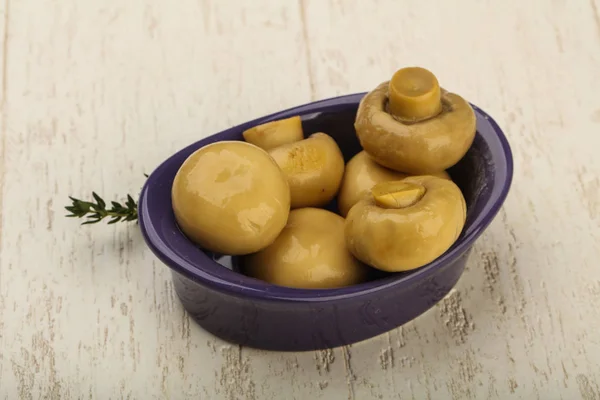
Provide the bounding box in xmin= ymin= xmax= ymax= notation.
xmin=269 ymin=132 xmax=345 ymax=208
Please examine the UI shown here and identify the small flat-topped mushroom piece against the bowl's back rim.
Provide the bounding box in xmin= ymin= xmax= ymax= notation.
xmin=242 ymin=116 xmax=304 ymax=150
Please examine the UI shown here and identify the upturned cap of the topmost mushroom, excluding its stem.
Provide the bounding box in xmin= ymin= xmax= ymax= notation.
xmin=354 ymin=82 xmax=476 ymax=174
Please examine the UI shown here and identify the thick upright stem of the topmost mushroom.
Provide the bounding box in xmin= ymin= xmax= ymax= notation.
xmin=389 ymin=67 xmax=442 ymax=122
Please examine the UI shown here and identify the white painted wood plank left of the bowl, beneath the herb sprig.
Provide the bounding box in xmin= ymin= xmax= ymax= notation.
xmin=0 ymin=0 xmax=310 ymax=399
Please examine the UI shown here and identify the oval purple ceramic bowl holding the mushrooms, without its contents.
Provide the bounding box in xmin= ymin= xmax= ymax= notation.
xmin=139 ymin=93 xmax=513 ymax=351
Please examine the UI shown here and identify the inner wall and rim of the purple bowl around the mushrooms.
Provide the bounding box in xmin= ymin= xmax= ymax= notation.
xmin=139 ymin=93 xmax=512 ymax=300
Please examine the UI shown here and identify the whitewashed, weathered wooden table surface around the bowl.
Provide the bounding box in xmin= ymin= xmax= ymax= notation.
xmin=0 ymin=0 xmax=600 ymax=400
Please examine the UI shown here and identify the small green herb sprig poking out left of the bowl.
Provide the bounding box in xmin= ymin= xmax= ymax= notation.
xmin=65 ymin=192 xmax=138 ymax=225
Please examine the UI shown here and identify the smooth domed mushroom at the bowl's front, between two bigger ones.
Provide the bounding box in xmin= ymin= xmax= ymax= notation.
xmin=242 ymin=208 xmax=368 ymax=289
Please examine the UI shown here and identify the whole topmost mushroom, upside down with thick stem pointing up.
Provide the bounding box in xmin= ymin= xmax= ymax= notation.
xmin=354 ymin=67 xmax=476 ymax=175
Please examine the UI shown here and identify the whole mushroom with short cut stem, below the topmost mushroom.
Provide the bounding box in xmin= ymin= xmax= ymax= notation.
xmin=345 ymin=175 xmax=466 ymax=272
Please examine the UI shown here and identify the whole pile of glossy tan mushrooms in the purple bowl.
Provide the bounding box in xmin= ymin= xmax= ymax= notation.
xmin=172 ymin=67 xmax=476 ymax=289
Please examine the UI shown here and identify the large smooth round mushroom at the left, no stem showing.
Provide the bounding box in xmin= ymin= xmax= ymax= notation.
xmin=171 ymin=141 xmax=290 ymax=255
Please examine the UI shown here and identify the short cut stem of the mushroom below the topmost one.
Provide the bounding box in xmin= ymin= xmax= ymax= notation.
xmin=371 ymin=181 xmax=426 ymax=209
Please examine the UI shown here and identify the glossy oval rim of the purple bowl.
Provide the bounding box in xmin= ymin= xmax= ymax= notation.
xmin=138 ymin=92 xmax=513 ymax=303
